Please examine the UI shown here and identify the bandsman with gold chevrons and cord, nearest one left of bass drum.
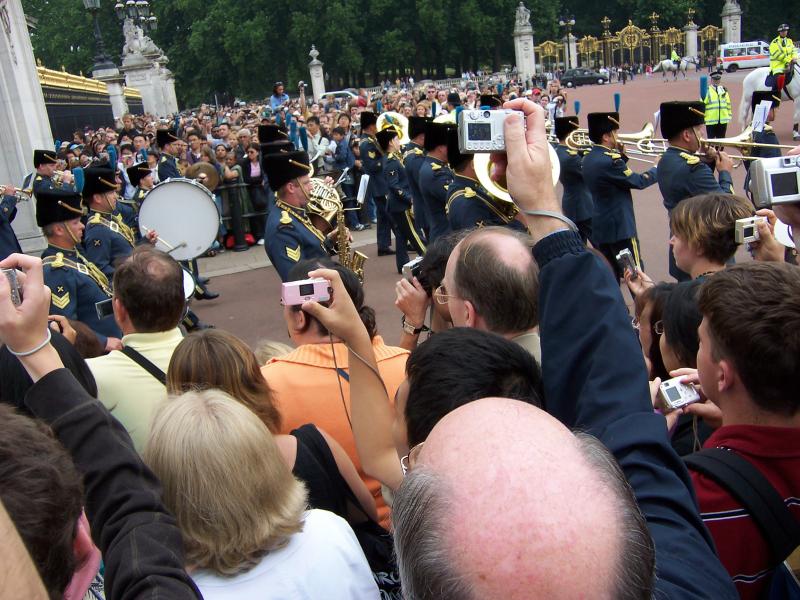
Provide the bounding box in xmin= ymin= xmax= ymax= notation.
xmin=36 ymin=190 xmax=122 ymax=352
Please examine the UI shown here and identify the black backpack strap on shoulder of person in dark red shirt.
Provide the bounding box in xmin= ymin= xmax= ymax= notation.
xmin=683 ymin=448 xmax=800 ymax=566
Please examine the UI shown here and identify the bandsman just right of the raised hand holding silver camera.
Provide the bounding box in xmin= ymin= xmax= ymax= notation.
xmin=553 ymin=116 xmax=594 ymax=242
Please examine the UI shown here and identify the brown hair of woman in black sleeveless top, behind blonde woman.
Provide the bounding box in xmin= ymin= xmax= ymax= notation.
xmin=167 ymin=329 xmax=281 ymax=433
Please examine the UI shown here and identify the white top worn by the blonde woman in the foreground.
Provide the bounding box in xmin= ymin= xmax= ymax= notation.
xmin=192 ymin=509 xmax=380 ymax=600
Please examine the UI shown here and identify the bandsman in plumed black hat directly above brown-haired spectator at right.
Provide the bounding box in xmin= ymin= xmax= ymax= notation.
xmin=658 ymin=101 xmax=733 ymax=281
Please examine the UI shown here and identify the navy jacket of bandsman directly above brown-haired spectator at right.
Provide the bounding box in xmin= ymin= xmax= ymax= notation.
xmin=658 ymin=146 xmax=733 ymax=212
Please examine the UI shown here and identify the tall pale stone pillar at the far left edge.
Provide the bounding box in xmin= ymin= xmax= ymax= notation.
xmin=0 ymin=0 xmax=48 ymax=252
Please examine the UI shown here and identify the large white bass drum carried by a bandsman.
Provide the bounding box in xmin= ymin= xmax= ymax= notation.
xmin=139 ymin=178 xmax=219 ymax=260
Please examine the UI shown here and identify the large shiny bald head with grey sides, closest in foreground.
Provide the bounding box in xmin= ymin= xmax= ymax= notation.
xmin=393 ymin=398 xmax=655 ymax=600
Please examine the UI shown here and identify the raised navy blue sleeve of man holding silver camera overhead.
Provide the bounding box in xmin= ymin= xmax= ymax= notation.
xmin=533 ymin=231 xmax=738 ymax=599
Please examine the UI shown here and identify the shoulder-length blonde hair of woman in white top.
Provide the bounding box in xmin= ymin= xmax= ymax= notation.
xmin=144 ymin=390 xmax=307 ymax=576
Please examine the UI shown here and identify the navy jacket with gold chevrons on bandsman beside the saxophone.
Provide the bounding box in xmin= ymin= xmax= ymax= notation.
xmin=264 ymin=200 xmax=328 ymax=281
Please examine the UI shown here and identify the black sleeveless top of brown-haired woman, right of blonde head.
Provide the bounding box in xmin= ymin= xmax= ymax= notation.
xmin=291 ymin=423 xmax=348 ymax=520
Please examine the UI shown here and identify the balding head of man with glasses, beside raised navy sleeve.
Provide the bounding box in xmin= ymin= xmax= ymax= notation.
xmin=444 ymin=227 xmax=539 ymax=336
